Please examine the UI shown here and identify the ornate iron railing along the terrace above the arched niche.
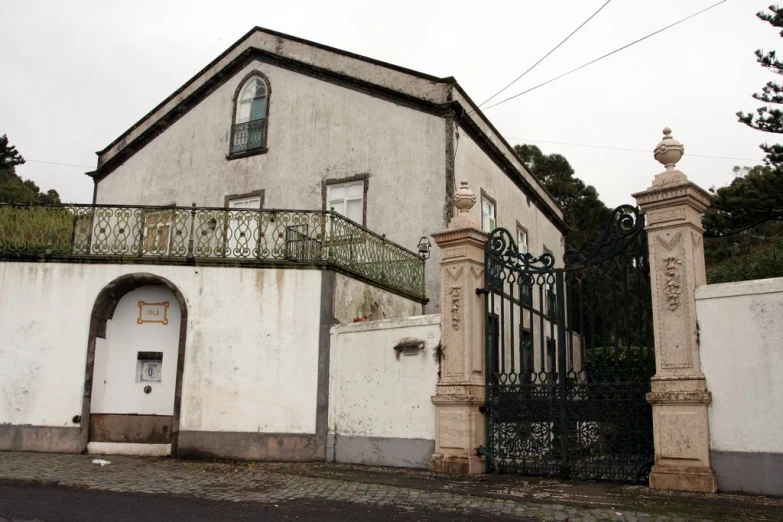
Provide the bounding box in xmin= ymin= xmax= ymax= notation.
xmin=0 ymin=204 xmax=426 ymax=301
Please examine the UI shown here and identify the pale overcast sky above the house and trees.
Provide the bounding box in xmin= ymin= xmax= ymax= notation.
xmin=0 ymin=0 xmax=783 ymax=206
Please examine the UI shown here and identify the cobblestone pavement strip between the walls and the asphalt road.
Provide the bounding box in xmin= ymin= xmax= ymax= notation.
xmin=0 ymin=452 xmax=783 ymax=522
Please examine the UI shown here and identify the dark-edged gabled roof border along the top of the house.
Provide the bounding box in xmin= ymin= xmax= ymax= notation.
xmin=87 ymin=27 xmax=565 ymax=230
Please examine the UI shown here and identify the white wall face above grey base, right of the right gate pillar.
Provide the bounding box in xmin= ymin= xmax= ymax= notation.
xmin=696 ymin=278 xmax=783 ymax=453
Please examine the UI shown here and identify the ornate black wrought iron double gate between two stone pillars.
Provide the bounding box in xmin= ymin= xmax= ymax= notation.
xmin=480 ymin=205 xmax=655 ymax=482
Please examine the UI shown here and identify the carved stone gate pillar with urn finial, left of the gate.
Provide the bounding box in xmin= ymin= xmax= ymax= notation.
xmin=430 ymin=181 xmax=487 ymax=474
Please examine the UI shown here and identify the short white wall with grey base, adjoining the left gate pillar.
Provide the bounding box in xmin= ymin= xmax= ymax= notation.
xmin=327 ymin=315 xmax=440 ymax=467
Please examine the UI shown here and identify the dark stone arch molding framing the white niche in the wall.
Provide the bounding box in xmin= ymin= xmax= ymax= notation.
xmin=79 ymin=272 xmax=188 ymax=456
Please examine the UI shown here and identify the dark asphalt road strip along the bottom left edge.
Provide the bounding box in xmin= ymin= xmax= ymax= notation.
xmin=0 ymin=482 xmax=535 ymax=522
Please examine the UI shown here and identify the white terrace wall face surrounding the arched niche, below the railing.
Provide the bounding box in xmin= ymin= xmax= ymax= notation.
xmin=0 ymin=263 xmax=321 ymax=433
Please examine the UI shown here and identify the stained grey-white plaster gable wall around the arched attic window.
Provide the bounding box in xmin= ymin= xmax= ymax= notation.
xmin=96 ymin=60 xmax=446 ymax=311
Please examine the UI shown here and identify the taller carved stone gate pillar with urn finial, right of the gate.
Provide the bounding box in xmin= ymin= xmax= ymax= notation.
xmin=633 ymin=127 xmax=717 ymax=492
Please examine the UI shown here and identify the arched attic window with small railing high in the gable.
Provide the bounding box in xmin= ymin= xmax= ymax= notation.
xmin=229 ymin=73 xmax=269 ymax=156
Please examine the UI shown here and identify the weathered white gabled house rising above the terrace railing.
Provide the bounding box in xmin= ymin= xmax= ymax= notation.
xmin=88 ymin=27 xmax=565 ymax=313
